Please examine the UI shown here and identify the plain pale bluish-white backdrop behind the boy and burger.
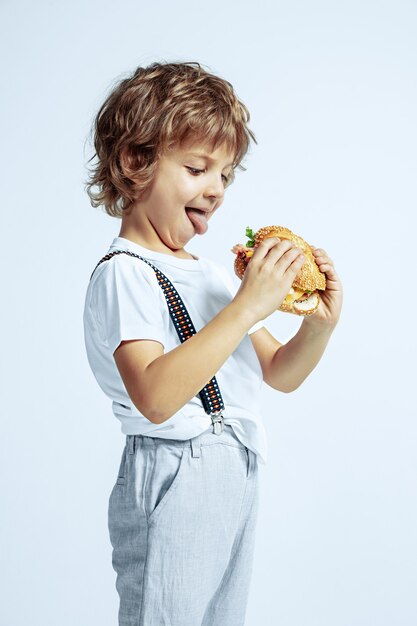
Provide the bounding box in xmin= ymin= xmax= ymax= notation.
xmin=0 ymin=0 xmax=417 ymax=626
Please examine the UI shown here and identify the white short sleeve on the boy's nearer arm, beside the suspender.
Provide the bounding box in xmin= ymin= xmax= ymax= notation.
xmin=94 ymin=255 xmax=165 ymax=354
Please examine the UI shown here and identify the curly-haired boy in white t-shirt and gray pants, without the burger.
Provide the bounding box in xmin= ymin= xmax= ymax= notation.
xmin=84 ymin=62 xmax=342 ymax=626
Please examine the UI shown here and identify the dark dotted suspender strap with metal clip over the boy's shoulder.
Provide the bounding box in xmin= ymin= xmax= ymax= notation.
xmin=90 ymin=250 xmax=224 ymax=435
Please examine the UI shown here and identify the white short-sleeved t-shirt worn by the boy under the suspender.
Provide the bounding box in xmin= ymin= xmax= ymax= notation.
xmin=83 ymin=237 xmax=267 ymax=464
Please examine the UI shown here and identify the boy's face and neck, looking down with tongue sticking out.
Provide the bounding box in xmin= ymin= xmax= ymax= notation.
xmin=122 ymin=136 xmax=234 ymax=254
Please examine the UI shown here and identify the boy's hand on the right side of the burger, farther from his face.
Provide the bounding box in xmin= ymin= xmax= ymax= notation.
xmin=304 ymin=246 xmax=343 ymax=328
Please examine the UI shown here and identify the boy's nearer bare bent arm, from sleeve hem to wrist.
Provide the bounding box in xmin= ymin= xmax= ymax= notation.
xmin=114 ymin=299 xmax=258 ymax=424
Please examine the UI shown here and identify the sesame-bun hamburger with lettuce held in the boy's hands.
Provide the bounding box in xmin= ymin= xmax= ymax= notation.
xmin=231 ymin=226 xmax=326 ymax=315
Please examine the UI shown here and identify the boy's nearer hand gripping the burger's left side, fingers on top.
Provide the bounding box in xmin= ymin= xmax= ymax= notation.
xmin=234 ymin=237 xmax=305 ymax=322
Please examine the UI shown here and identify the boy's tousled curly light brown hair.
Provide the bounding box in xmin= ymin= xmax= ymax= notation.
xmin=85 ymin=62 xmax=257 ymax=217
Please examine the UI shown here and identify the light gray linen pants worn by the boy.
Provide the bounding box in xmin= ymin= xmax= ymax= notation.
xmin=108 ymin=425 xmax=259 ymax=626
